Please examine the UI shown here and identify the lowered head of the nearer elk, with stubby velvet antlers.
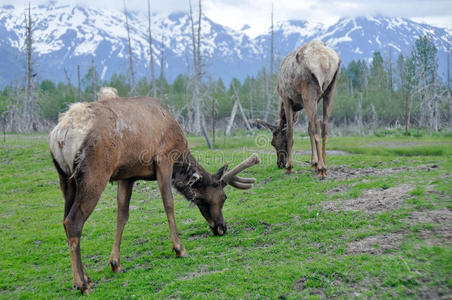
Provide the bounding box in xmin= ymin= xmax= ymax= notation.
xmin=176 ymin=154 xmax=260 ymax=236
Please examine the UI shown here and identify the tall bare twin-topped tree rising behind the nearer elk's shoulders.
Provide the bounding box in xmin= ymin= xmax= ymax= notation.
xmin=188 ymin=0 xmax=202 ymax=134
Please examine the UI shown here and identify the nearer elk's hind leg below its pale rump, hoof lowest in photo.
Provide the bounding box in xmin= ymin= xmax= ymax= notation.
xmin=63 ymin=177 xmax=108 ymax=294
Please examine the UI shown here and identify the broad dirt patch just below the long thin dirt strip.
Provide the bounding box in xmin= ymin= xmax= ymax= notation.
xmin=322 ymin=184 xmax=412 ymax=213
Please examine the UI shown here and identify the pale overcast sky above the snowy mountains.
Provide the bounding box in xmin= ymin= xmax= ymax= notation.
xmin=4 ymin=0 xmax=452 ymax=35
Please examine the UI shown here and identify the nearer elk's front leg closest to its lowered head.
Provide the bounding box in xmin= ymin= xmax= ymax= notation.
xmin=157 ymin=158 xmax=187 ymax=257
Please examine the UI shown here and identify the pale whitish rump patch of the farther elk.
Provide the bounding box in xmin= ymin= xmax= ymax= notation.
xmin=302 ymin=41 xmax=340 ymax=91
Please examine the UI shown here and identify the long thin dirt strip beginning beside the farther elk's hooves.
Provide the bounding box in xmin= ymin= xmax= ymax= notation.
xmin=325 ymin=164 xmax=438 ymax=180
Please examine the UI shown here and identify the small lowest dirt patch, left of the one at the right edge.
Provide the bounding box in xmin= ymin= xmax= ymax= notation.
xmin=346 ymin=233 xmax=403 ymax=254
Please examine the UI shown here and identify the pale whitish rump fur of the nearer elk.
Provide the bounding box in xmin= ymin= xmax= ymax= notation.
xmin=49 ymin=103 xmax=95 ymax=174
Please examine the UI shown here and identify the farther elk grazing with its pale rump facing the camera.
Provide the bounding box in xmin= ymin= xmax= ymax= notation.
xmin=251 ymin=41 xmax=341 ymax=178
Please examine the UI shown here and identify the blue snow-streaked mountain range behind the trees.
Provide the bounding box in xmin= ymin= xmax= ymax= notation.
xmin=0 ymin=2 xmax=452 ymax=86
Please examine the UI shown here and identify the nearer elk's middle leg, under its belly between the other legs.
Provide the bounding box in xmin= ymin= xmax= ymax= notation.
xmin=110 ymin=180 xmax=133 ymax=272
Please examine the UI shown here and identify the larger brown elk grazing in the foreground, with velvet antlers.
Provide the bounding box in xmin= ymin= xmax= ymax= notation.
xmin=50 ymin=97 xmax=259 ymax=293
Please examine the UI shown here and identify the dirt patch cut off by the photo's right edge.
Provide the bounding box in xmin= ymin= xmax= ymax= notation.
xmin=406 ymin=209 xmax=452 ymax=246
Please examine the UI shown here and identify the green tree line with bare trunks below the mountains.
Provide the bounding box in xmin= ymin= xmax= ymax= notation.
xmin=0 ymin=1 xmax=452 ymax=134
